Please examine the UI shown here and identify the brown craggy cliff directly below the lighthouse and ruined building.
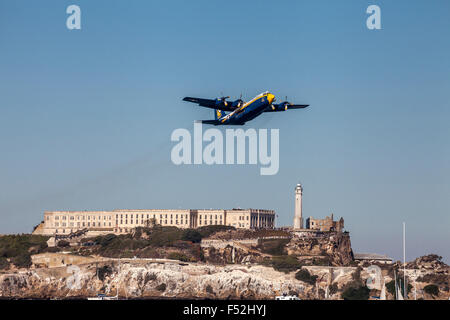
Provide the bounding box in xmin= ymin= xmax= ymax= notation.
xmin=286 ymin=232 xmax=353 ymax=266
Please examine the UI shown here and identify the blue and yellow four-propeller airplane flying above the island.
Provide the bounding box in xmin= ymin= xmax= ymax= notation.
xmin=183 ymin=91 xmax=309 ymax=126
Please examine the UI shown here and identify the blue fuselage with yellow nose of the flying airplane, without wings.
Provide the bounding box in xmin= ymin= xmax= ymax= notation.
xmin=218 ymin=92 xmax=275 ymax=125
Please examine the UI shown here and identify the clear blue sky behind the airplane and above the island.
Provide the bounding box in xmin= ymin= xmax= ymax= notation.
xmin=0 ymin=0 xmax=450 ymax=262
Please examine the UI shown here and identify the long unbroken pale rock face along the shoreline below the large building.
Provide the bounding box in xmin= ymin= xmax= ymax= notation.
xmin=0 ymin=262 xmax=313 ymax=299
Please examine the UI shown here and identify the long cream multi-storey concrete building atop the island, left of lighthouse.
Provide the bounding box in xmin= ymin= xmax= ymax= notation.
xmin=33 ymin=209 xmax=275 ymax=235
